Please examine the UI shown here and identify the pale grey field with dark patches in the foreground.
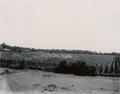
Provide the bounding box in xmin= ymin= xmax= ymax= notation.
xmin=0 ymin=68 xmax=120 ymax=94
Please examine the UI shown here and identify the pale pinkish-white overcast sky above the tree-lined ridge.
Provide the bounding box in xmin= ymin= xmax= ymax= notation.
xmin=0 ymin=0 xmax=120 ymax=52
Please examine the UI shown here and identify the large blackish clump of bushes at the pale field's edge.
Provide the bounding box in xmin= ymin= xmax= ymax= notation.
xmin=54 ymin=60 xmax=96 ymax=76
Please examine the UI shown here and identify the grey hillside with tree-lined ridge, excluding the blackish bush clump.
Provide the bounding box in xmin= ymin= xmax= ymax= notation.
xmin=0 ymin=44 xmax=120 ymax=76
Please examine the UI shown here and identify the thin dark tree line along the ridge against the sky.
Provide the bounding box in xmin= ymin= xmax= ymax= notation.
xmin=0 ymin=43 xmax=120 ymax=55
